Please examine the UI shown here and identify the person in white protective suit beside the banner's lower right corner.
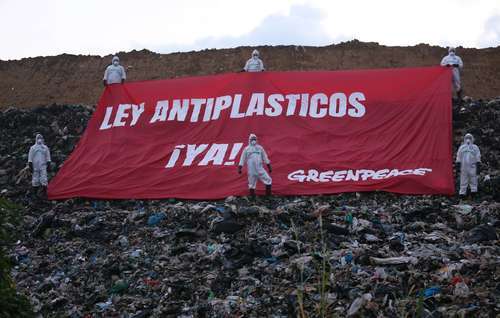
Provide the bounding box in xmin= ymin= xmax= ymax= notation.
xmin=456 ymin=134 xmax=481 ymax=195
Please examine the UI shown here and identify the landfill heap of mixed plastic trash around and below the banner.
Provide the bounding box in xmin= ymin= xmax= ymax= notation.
xmin=0 ymin=99 xmax=500 ymax=318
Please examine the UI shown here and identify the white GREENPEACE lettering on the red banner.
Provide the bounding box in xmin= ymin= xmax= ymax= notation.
xmin=288 ymin=168 xmax=432 ymax=182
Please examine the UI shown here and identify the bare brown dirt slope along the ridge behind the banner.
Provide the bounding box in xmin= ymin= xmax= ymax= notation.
xmin=0 ymin=41 xmax=500 ymax=108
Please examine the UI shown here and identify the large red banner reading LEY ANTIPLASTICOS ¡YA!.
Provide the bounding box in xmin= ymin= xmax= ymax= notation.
xmin=49 ymin=67 xmax=454 ymax=199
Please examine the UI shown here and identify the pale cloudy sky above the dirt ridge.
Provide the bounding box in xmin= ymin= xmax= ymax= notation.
xmin=0 ymin=0 xmax=500 ymax=60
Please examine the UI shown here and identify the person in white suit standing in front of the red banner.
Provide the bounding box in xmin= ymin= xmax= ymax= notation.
xmin=238 ymin=134 xmax=273 ymax=198
